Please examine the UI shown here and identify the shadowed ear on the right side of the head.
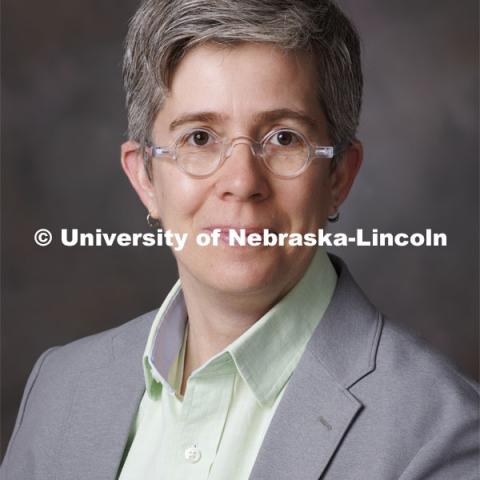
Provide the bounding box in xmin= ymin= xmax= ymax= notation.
xmin=329 ymin=140 xmax=363 ymax=215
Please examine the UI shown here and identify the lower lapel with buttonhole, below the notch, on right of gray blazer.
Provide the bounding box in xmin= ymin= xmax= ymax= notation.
xmin=250 ymin=353 xmax=361 ymax=480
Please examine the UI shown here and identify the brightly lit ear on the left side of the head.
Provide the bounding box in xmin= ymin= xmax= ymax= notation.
xmin=121 ymin=140 xmax=159 ymax=219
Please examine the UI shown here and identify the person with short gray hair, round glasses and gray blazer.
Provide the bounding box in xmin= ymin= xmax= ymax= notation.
xmin=2 ymin=0 xmax=479 ymax=480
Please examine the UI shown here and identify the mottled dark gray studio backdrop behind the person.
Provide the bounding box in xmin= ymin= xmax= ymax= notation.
xmin=1 ymin=0 xmax=479 ymax=458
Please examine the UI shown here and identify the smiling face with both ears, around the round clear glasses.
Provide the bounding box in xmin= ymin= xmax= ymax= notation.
xmin=122 ymin=44 xmax=361 ymax=299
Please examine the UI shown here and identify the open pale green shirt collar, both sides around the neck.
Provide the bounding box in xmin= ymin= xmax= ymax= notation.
xmin=144 ymin=248 xmax=337 ymax=405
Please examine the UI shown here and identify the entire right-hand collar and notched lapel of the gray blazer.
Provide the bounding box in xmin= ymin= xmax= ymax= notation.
xmin=250 ymin=257 xmax=382 ymax=480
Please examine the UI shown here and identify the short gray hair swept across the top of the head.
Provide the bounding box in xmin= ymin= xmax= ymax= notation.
xmin=123 ymin=0 xmax=363 ymax=145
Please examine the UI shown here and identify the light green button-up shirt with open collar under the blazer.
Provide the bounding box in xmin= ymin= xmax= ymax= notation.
xmin=119 ymin=249 xmax=337 ymax=480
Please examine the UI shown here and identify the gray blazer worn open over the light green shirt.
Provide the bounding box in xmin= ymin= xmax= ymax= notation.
xmin=1 ymin=259 xmax=480 ymax=480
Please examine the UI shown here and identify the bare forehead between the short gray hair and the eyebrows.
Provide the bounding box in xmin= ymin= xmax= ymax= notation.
xmin=156 ymin=43 xmax=322 ymax=133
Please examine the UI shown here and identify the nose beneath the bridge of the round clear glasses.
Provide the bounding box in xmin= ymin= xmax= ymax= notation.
xmin=215 ymin=137 xmax=270 ymax=202
